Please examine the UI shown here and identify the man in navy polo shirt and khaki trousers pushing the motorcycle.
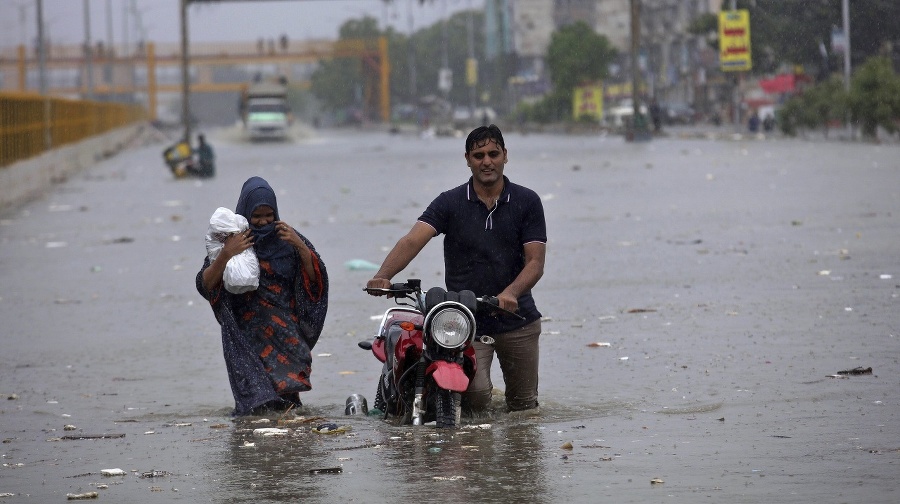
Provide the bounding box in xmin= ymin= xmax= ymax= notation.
xmin=366 ymin=124 xmax=547 ymax=412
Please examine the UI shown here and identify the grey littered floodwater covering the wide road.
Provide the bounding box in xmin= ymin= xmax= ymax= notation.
xmin=0 ymin=124 xmax=900 ymax=504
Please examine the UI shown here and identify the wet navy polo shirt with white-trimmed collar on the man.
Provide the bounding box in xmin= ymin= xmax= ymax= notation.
xmin=419 ymin=176 xmax=547 ymax=335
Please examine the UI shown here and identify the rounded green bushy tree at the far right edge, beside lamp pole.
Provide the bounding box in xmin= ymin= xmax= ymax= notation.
xmin=850 ymin=57 xmax=900 ymax=138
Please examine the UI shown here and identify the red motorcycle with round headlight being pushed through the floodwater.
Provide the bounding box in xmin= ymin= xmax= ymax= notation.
xmin=359 ymin=279 xmax=521 ymax=428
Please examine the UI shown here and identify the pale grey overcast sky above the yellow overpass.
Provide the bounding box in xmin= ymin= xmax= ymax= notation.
xmin=0 ymin=0 xmax=484 ymax=47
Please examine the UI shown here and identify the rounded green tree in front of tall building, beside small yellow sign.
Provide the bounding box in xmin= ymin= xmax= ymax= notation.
xmin=520 ymin=21 xmax=616 ymax=121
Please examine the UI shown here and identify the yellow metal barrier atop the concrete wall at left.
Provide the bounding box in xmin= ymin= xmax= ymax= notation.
xmin=0 ymin=93 xmax=147 ymax=168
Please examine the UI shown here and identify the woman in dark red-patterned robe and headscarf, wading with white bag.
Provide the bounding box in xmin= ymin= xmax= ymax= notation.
xmin=196 ymin=177 xmax=328 ymax=416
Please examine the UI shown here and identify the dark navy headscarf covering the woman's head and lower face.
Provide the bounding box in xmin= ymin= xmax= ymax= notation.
xmin=235 ymin=177 xmax=296 ymax=273
